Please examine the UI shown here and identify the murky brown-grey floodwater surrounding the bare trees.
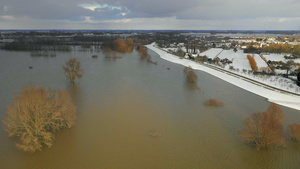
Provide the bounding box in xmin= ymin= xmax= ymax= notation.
xmin=0 ymin=46 xmax=300 ymax=169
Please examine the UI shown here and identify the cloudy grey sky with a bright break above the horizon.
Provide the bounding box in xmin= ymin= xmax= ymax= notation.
xmin=0 ymin=0 xmax=300 ymax=30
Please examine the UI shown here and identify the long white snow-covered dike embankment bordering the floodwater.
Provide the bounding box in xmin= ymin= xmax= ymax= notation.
xmin=147 ymin=44 xmax=300 ymax=110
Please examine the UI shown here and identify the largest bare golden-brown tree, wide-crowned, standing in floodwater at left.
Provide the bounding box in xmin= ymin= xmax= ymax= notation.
xmin=3 ymin=84 xmax=76 ymax=152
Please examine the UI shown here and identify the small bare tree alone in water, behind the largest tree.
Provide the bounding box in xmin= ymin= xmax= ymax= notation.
xmin=63 ymin=58 xmax=83 ymax=84
